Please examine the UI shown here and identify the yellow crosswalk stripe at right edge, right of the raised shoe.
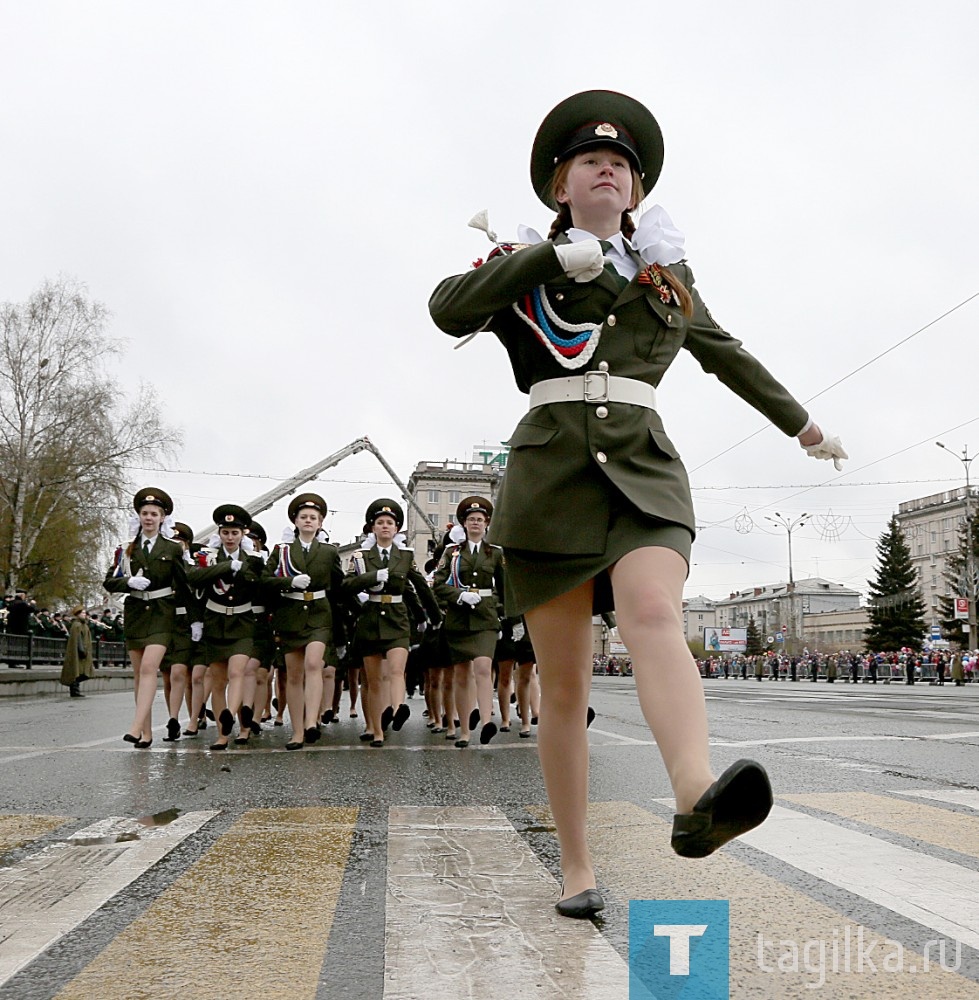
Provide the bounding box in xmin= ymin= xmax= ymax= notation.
xmin=780 ymin=792 xmax=979 ymax=858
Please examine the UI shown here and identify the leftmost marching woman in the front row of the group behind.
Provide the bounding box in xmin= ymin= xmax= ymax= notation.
xmin=103 ymin=486 xmax=185 ymax=750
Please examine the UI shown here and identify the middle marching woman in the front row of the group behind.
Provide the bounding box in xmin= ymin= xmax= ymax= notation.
xmin=265 ymin=493 xmax=343 ymax=750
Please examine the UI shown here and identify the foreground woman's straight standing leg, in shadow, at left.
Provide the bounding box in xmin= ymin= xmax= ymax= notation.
xmin=525 ymin=581 xmax=595 ymax=899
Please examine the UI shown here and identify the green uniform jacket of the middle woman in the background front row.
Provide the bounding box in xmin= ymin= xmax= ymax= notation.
xmin=262 ymin=538 xmax=343 ymax=643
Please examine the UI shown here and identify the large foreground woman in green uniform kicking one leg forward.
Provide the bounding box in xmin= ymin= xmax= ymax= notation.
xmin=430 ymin=91 xmax=846 ymax=917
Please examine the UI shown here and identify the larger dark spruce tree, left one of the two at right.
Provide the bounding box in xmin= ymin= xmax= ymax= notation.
xmin=864 ymin=517 xmax=927 ymax=651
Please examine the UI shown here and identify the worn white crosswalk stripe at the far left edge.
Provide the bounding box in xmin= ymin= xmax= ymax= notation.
xmin=0 ymin=812 xmax=217 ymax=984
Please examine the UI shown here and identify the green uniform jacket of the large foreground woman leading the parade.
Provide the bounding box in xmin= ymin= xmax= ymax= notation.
xmin=429 ymin=241 xmax=808 ymax=555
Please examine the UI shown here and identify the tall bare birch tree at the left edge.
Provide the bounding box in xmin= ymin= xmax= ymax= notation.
xmin=0 ymin=278 xmax=179 ymax=592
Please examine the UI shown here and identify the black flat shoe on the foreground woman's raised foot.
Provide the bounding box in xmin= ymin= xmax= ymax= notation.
xmin=670 ymin=760 xmax=772 ymax=858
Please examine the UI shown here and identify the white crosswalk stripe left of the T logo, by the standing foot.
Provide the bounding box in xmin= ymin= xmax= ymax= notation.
xmin=384 ymin=806 xmax=629 ymax=1000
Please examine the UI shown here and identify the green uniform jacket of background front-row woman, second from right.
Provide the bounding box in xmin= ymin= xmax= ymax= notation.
xmin=343 ymin=545 xmax=442 ymax=642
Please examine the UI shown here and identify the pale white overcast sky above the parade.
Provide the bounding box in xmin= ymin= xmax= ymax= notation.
xmin=0 ymin=0 xmax=979 ymax=598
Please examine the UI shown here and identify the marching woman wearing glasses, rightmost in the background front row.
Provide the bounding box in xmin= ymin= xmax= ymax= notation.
xmin=435 ymin=497 xmax=503 ymax=748
